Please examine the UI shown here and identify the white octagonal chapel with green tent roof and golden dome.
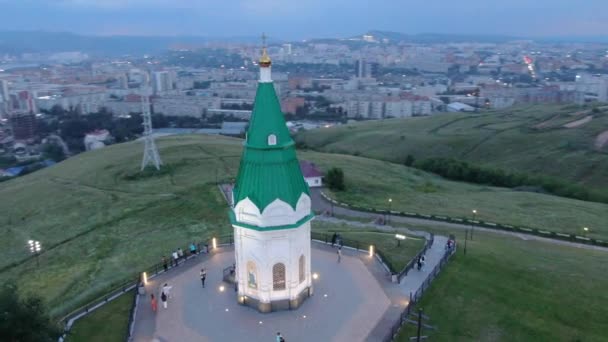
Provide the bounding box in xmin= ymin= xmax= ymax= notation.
xmin=230 ymin=49 xmax=314 ymax=312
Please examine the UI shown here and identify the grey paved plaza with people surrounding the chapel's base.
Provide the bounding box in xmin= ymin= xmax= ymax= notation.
xmin=134 ymin=243 xmax=398 ymax=342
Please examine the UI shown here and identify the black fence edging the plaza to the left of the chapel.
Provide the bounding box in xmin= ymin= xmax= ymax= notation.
xmin=59 ymin=234 xmax=234 ymax=341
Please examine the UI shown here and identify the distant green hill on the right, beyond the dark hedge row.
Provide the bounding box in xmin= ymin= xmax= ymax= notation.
xmin=297 ymin=106 xmax=608 ymax=191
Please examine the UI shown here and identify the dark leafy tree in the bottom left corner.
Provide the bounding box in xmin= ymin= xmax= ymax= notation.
xmin=0 ymin=282 xmax=61 ymax=342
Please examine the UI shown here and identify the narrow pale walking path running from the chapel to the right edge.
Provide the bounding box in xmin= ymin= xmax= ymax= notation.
xmin=310 ymin=188 xmax=608 ymax=251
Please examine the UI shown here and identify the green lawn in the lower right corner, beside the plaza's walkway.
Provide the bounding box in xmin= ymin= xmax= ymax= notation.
xmin=397 ymin=229 xmax=608 ymax=342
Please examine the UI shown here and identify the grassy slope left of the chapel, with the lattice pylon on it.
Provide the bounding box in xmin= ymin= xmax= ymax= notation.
xmin=0 ymin=137 xmax=241 ymax=314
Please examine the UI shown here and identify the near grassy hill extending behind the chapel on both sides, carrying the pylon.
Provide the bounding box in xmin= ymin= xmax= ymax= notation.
xmin=0 ymin=136 xmax=608 ymax=314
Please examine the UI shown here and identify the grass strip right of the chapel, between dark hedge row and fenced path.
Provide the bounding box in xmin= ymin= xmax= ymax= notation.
xmin=314 ymin=152 xmax=608 ymax=240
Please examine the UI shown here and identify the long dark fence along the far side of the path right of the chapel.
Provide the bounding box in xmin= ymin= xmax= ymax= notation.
xmin=321 ymin=192 xmax=608 ymax=247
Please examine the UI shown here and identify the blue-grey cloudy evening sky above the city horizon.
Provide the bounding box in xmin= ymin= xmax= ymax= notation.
xmin=0 ymin=0 xmax=608 ymax=39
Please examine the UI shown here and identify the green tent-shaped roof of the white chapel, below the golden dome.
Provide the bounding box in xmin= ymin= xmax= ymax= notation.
xmin=233 ymin=83 xmax=309 ymax=215
